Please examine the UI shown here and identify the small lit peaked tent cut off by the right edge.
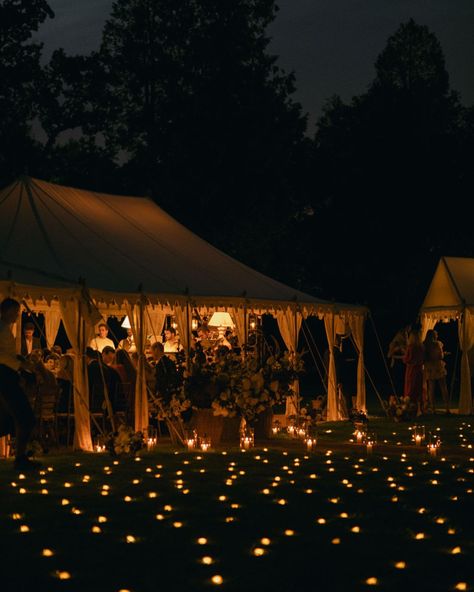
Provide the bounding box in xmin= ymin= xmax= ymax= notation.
xmin=421 ymin=257 xmax=474 ymax=414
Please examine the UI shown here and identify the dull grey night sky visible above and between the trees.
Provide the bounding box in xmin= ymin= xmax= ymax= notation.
xmin=35 ymin=0 xmax=474 ymax=132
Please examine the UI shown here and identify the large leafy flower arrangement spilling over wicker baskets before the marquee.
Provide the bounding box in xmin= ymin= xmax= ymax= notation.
xmin=184 ymin=351 xmax=303 ymax=421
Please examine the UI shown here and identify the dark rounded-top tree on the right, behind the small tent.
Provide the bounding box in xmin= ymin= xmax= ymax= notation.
xmin=301 ymin=20 xmax=473 ymax=330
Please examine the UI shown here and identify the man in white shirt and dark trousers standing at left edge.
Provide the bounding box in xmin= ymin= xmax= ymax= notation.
xmin=0 ymin=298 xmax=41 ymax=471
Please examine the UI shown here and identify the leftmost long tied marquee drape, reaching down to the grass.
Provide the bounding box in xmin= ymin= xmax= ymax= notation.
xmin=60 ymin=300 xmax=92 ymax=451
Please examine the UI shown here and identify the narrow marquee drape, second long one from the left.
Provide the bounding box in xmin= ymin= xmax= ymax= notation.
xmin=127 ymin=302 xmax=148 ymax=433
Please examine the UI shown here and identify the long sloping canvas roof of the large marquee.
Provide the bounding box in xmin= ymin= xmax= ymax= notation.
xmin=0 ymin=177 xmax=366 ymax=312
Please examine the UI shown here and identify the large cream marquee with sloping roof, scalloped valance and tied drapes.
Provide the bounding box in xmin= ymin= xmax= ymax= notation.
xmin=0 ymin=177 xmax=367 ymax=450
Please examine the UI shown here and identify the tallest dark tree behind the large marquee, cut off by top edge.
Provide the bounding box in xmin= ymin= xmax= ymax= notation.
xmin=59 ymin=0 xmax=309 ymax=271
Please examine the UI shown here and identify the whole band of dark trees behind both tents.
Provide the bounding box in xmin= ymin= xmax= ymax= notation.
xmin=0 ymin=0 xmax=474 ymax=338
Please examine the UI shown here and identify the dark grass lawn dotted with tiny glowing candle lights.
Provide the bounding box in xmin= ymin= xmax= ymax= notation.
xmin=0 ymin=416 xmax=474 ymax=592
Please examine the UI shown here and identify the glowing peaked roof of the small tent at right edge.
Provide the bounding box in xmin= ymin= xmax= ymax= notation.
xmin=421 ymin=257 xmax=474 ymax=314
